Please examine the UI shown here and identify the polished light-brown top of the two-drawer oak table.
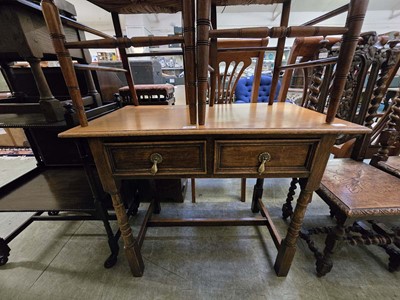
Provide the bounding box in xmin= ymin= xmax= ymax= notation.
xmin=59 ymin=102 xmax=370 ymax=138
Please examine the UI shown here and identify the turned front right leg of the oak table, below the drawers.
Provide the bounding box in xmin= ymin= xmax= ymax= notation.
xmin=274 ymin=190 xmax=313 ymax=276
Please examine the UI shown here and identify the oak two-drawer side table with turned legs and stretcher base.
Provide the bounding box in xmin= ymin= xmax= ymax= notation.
xmin=59 ymin=103 xmax=370 ymax=276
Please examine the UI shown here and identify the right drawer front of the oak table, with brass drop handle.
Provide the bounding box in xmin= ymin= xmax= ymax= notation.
xmin=214 ymin=139 xmax=318 ymax=176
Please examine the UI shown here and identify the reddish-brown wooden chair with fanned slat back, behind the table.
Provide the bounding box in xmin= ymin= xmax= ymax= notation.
xmin=191 ymin=39 xmax=268 ymax=203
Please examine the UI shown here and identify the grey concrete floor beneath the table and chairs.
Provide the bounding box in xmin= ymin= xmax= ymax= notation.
xmin=0 ymin=159 xmax=400 ymax=300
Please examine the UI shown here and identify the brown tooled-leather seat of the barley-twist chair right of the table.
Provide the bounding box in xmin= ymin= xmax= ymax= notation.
xmin=317 ymin=159 xmax=400 ymax=218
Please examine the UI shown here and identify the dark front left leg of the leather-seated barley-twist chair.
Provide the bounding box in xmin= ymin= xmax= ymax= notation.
xmin=316 ymin=219 xmax=345 ymax=277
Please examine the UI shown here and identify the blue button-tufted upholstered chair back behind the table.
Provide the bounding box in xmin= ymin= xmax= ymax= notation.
xmin=235 ymin=75 xmax=281 ymax=103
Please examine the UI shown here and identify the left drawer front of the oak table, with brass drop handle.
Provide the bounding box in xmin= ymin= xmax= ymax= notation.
xmin=105 ymin=141 xmax=207 ymax=177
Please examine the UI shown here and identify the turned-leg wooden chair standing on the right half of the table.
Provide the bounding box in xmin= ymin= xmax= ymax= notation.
xmin=197 ymin=0 xmax=368 ymax=125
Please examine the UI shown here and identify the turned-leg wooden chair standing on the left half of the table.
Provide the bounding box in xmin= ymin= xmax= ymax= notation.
xmin=42 ymin=0 xmax=196 ymax=124
